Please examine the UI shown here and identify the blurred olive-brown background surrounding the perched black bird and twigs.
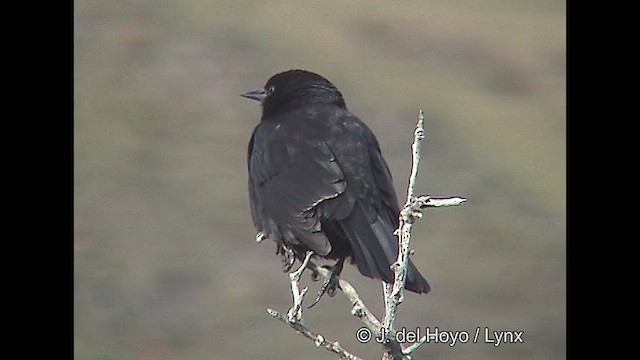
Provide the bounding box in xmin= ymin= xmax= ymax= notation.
xmin=74 ymin=0 xmax=566 ymax=360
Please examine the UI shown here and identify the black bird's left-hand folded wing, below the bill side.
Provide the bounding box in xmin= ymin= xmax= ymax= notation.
xmin=248 ymin=122 xmax=346 ymax=256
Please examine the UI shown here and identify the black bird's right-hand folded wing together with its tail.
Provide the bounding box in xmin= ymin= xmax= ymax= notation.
xmin=320 ymin=114 xmax=429 ymax=293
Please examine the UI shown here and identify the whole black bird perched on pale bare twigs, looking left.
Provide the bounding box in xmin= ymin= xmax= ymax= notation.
xmin=242 ymin=70 xmax=430 ymax=304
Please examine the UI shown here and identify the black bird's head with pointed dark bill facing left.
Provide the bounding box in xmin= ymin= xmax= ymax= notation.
xmin=240 ymin=70 xmax=346 ymax=119
